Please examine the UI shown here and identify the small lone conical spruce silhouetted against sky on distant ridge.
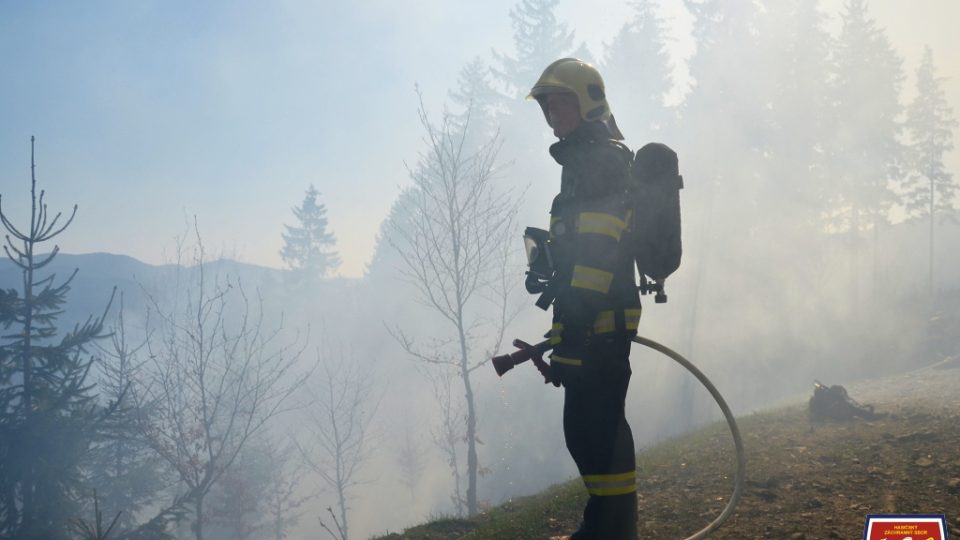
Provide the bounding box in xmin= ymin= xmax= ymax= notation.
xmin=280 ymin=185 xmax=340 ymax=283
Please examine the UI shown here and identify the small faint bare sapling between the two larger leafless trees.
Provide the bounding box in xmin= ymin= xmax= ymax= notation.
xmin=297 ymin=349 xmax=379 ymax=540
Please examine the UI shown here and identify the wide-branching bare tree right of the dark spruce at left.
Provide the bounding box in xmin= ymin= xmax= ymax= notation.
xmin=134 ymin=226 xmax=304 ymax=540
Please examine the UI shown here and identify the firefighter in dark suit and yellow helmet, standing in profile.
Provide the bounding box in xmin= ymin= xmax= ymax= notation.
xmin=527 ymin=58 xmax=640 ymax=540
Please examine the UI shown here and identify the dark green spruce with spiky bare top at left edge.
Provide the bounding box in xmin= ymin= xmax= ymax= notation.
xmin=0 ymin=138 xmax=110 ymax=540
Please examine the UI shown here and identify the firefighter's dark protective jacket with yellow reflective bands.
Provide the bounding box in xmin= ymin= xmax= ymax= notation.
xmin=550 ymin=122 xmax=640 ymax=354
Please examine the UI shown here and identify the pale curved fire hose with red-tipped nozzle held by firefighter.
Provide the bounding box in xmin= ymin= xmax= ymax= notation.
xmin=492 ymin=336 xmax=747 ymax=540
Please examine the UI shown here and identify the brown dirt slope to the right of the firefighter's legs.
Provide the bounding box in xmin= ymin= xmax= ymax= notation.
xmin=616 ymin=359 xmax=960 ymax=540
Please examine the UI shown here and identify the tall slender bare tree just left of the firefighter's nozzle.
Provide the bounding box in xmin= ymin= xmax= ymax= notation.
xmin=387 ymin=96 xmax=520 ymax=515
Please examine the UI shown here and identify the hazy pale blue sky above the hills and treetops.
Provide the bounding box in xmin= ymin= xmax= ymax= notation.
xmin=0 ymin=0 xmax=960 ymax=276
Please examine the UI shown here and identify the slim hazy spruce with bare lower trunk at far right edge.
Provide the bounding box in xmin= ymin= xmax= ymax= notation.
xmin=903 ymin=46 xmax=957 ymax=293
